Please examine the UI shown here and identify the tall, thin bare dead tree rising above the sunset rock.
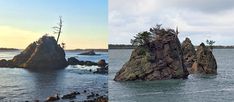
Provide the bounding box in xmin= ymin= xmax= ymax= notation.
xmin=53 ymin=16 xmax=63 ymax=43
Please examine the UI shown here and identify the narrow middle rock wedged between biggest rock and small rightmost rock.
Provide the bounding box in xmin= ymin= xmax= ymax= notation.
xmin=181 ymin=38 xmax=196 ymax=72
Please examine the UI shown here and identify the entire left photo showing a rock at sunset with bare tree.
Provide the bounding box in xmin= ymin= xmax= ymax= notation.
xmin=0 ymin=0 xmax=108 ymax=102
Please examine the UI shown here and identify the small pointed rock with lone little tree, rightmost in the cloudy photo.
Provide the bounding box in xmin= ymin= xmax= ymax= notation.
xmin=191 ymin=43 xmax=217 ymax=74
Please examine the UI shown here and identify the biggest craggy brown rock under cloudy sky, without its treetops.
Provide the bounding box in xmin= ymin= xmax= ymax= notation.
xmin=114 ymin=29 xmax=188 ymax=81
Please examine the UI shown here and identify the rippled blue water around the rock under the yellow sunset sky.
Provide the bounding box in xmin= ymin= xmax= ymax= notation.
xmin=0 ymin=51 xmax=108 ymax=102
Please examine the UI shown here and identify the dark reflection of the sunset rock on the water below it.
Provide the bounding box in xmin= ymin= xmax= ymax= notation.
xmin=23 ymin=70 xmax=64 ymax=99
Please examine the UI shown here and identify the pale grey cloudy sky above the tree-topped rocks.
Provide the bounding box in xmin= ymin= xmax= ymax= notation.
xmin=108 ymin=0 xmax=234 ymax=45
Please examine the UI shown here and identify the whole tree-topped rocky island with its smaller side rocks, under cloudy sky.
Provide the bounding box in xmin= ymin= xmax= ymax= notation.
xmin=114 ymin=25 xmax=217 ymax=81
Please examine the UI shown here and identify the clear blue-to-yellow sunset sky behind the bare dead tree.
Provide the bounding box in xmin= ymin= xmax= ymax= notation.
xmin=0 ymin=0 xmax=108 ymax=49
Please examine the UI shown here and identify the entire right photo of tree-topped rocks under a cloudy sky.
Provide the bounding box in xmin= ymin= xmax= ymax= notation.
xmin=108 ymin=0 xmax=234 ymax=102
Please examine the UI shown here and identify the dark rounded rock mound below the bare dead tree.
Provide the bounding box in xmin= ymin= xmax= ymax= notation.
xmin=12 ymin=35 xmax=68 ymax=69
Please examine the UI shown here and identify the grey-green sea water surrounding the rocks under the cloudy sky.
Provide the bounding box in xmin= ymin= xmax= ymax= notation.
xmin=108 ymin=49 xmax=234 ymax=102
